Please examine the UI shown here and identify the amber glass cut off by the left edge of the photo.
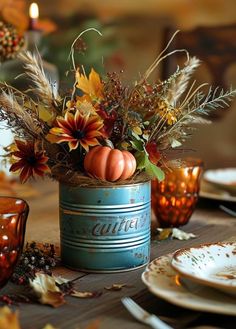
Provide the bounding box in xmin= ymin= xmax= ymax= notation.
xmin=0 ymin=197 xmax=29 ymax=288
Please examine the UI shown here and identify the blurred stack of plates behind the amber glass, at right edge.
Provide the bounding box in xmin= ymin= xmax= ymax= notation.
xmin=200 ymin=168 xmax=236 ymax=202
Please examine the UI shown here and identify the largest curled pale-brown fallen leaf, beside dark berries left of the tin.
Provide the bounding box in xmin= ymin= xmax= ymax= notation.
xmin=30 ymin=273 xmax=65 ymax=307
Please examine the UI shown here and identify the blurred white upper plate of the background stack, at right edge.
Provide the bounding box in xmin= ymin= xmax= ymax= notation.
xmin=203 ymin=168 xmax=236 ymax=194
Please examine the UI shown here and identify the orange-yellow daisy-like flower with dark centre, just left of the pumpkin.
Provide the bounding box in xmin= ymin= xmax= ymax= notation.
xmin=47 ymin=110 xmax=103 ymax=152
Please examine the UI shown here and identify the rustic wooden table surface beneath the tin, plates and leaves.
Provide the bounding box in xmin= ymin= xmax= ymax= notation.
xmin=1 ymin=181 xmax=236 ymax=329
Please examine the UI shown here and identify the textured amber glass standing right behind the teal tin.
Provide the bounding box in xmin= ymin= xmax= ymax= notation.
xmin=152 ymin=159 xmax=203 ymax=227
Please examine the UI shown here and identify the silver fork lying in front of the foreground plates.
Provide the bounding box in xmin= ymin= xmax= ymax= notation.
xmin=121 ymin=297 xmax=173 ymax=329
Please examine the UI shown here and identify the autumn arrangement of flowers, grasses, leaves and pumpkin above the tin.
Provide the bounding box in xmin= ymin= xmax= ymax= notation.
xmin=0 ymin=29 xmax=236 ymax=185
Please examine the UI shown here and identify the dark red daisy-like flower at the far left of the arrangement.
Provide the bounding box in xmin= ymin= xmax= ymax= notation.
xmin=10 ymin=140 xmax=50 ymax=183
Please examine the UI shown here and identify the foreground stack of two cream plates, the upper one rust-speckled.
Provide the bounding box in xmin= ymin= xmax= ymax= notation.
xmin=142 ymin=242 xmax=236 ymax=316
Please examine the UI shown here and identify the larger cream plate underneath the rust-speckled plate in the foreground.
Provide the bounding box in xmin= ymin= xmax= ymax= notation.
xmin=142 ymin=255 xmax=236 ymax=316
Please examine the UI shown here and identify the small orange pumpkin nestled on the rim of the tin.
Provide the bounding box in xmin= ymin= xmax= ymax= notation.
xmin=84 ymin=146 xmax=136 ymax=182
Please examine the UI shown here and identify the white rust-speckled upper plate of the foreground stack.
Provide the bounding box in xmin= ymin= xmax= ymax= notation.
xmin=171 ymin=242 xmax=236 ymax=295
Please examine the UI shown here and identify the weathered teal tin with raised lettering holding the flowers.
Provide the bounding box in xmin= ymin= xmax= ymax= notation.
xmin=59 ymin=181 xmax=151 ymax=272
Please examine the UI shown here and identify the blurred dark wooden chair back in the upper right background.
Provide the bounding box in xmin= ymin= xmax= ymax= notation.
xmin=162 ymin=24 xmax=236 ymax=119
